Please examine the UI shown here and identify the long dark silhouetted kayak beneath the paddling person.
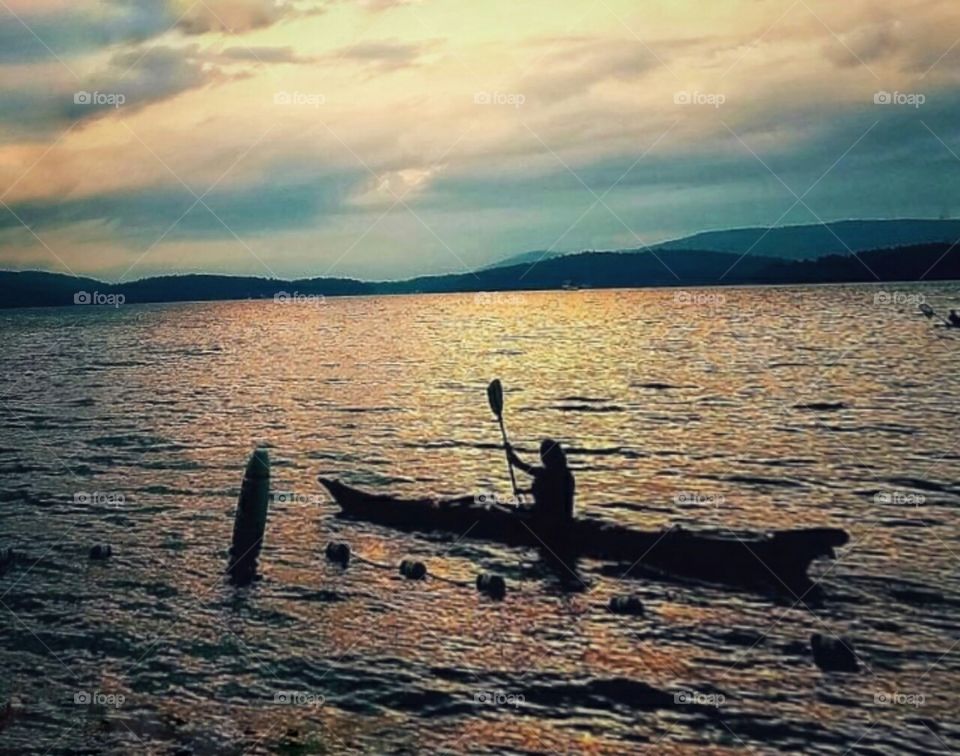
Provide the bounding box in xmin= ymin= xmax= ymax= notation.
xmin=319 ymin=478 xmax=849 ymax=596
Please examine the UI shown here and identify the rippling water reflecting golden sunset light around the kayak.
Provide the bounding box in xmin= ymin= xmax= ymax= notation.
xmin=0 ymin=285 xmax=960 ymax=754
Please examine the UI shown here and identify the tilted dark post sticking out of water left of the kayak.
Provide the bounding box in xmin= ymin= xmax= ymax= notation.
xmin=228 ymin=449 xmax=270 ymax=585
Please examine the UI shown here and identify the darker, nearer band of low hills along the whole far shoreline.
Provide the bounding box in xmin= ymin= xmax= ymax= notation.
xmin=0 ymin=244 xmax=960 ymax=308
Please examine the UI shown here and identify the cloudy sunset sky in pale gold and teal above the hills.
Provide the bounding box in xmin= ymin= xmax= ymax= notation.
xmin=0 ymin=0 xmax=960 ymax=281
